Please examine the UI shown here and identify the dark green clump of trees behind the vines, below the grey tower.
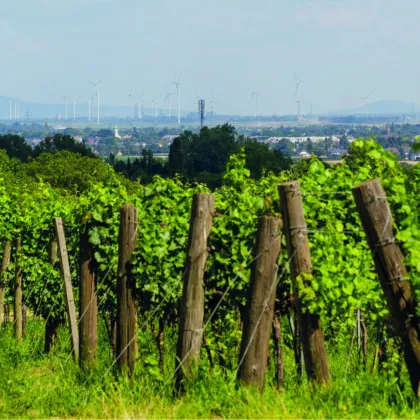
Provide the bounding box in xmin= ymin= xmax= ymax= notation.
xmin=109 ymin=124 xmax=292 ymax=188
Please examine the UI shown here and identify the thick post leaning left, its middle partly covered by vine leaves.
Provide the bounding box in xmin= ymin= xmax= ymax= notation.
xmin=279 ymin=181 xmax=330 ymax=383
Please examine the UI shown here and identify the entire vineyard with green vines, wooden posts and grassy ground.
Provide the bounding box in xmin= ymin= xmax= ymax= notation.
xmin=0 ymin=140 xmax=420 ymax=418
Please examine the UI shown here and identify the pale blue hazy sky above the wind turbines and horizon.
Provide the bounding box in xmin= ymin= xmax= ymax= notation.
xmin=0 ymin=0 xmax=420 ymax=114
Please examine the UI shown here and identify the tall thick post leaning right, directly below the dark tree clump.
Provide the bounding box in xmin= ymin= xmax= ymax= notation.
xmin=176 ymin=194 xmax=214 ymax=388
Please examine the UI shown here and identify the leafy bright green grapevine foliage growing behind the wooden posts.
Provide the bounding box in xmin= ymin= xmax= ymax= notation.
xmin=0 ymin=140 xmax=420 ymax=388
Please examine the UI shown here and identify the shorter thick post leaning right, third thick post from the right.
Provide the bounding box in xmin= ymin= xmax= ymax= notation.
xmin=238 ymin=216 xmax=281 ymax=391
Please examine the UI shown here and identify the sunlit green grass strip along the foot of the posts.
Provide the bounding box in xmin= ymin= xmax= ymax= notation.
xmin=0 ymin=321 xmax=420 ymax=418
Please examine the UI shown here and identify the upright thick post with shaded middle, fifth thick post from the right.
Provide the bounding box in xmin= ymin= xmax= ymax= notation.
xmin=117 ymin=204 xmax=138 ymax=376
